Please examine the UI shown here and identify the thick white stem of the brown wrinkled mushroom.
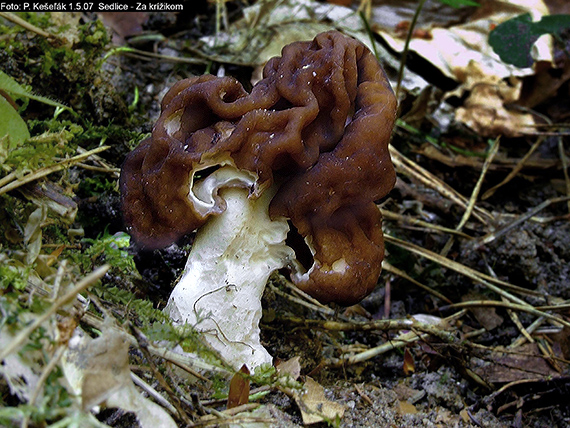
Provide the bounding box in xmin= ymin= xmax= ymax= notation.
xmin=166 ymin=167 xmax=288 ymax=371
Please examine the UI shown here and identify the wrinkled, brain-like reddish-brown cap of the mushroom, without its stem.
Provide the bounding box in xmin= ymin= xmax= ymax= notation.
xmin=121 ymin=31 xmax=397 ymax=305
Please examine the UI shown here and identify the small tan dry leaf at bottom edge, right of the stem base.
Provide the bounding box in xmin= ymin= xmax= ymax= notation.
xmin=295 ymin=377 xmax=346 ymax=425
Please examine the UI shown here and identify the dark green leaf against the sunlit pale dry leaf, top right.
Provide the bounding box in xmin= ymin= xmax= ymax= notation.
xmin=489 ymin=13 xmax=570 ymax=68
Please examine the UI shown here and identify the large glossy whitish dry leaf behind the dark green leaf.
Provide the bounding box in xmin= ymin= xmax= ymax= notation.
xmin=372 ymin=0 xmax=552 ymax=82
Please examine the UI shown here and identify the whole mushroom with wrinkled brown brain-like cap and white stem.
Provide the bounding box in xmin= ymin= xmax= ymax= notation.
xmin=121 ymin=31 xmax=397 ymax=368
